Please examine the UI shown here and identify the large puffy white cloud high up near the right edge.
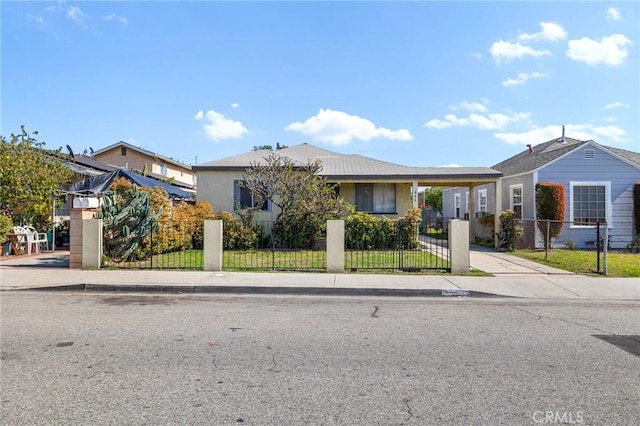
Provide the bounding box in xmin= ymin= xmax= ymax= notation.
xmin=567 ymin=34 xmax=631 ymax=66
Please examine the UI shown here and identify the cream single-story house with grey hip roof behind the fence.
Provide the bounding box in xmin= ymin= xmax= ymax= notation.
xmin=193 ymin=143 xmax=502 ymax=226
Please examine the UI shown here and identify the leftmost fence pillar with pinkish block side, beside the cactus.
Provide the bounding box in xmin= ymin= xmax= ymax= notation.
xmin=69 ymin=208 xmax=103 ymax=269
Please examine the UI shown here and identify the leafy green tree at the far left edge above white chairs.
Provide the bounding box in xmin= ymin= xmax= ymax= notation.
xmin=0 ymin=126 xmax=72 ymax=227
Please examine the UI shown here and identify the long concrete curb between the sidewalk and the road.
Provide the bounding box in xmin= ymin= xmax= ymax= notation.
xmin=12 ymin=284 xmax=502 ymax=298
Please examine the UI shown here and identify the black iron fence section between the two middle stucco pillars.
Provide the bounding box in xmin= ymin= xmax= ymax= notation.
xmin=222 ymin=221 xmax=327 ymax=271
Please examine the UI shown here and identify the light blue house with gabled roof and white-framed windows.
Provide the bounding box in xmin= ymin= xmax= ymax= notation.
xmin=443 ymin=137 xmax=640 ymax=248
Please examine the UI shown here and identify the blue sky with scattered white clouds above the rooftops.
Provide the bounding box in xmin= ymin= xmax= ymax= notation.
xmin=0 ymin=1 xmax=640 ymax=166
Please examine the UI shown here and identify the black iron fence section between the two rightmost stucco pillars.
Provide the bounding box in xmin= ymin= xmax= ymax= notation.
xmin=345 ymin=222 xmax=451 ymax=272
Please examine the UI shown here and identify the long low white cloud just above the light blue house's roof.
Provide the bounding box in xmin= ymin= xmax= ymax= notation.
xmin=494 ymin=124 xmax=627 ymax=145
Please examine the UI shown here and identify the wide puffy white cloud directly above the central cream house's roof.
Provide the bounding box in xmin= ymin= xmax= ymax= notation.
xmin=285 ymin=109 xmax=413 ymax=145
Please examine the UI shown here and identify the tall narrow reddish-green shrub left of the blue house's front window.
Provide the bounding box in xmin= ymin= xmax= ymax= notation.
xmin=536 ymin=183 xmax=565 ymax=248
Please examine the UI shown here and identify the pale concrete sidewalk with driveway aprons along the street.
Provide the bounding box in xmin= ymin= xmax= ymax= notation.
xmin=0 ymin=247 xmax=640 ymax=301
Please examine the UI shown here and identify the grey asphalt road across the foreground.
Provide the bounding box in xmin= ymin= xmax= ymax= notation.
xmin=0 ymin=292 xmax=640 ymax=425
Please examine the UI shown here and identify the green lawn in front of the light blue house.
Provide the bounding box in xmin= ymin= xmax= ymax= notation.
xmin=511 ymin=249 xmax=640 ymax=277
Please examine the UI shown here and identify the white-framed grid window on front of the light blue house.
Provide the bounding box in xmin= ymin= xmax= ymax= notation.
xmin=569 ymin=182 xmax=611 ymax=226
